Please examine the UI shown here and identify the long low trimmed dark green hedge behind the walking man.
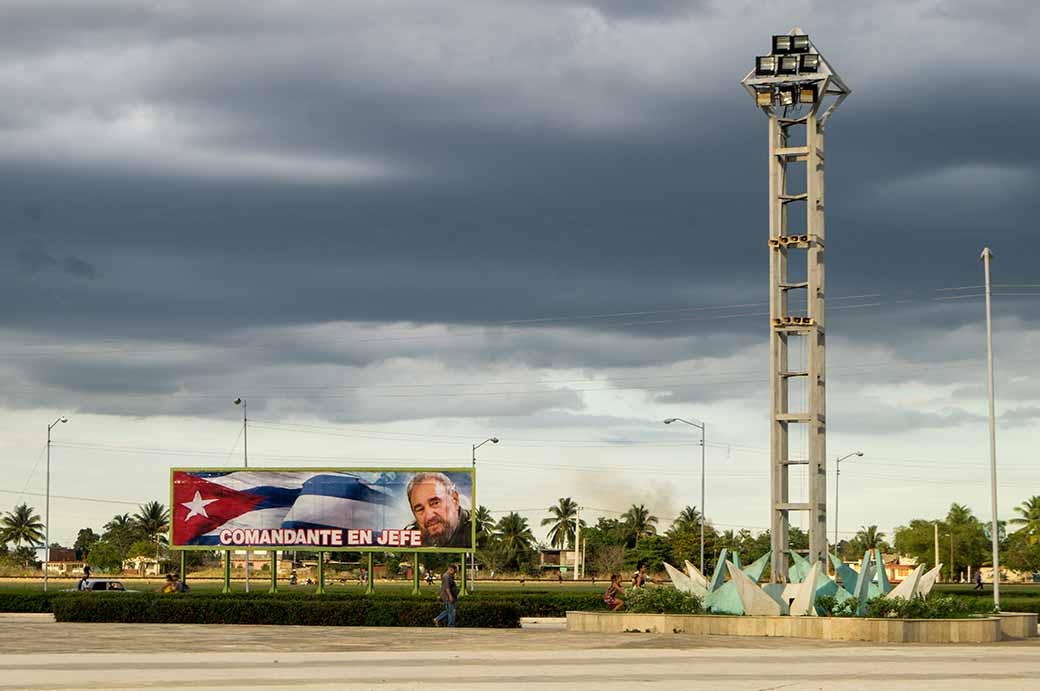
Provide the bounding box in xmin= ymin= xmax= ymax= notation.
xmin=53 ymin=593 xmax=521 ymax=629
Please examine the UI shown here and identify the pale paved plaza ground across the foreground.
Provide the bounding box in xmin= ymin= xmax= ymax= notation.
xmin=0 ymin=615 xmax=1040 ymax=691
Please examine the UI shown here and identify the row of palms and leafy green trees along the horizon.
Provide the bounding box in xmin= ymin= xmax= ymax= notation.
xmin=0 ymin=495 xmax=1040 ymax=580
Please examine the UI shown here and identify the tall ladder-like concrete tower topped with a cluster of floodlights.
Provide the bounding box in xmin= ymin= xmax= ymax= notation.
xmin=740 ymin=28 xmax=851 ymax=583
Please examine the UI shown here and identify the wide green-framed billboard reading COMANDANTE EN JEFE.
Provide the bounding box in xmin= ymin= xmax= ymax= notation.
xmin=170 ymin=468 xmax=475 ymax=552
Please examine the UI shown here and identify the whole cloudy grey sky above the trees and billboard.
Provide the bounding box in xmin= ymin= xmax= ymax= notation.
xmin=0 ymin=0 xmax=1040 ymax=542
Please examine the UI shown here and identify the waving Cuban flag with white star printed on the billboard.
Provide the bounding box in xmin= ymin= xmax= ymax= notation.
xmin=173 ymin=470 xmax=397 ymax=546
